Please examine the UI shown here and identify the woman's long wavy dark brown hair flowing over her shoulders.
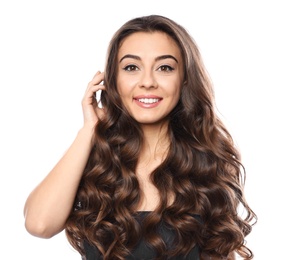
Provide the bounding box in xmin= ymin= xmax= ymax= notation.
xmin=65 ymin=15 xmax=257 ymax=260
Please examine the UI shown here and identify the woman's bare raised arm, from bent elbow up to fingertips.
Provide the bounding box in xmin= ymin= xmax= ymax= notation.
xmin=24 ymin=72 xmax=104 ymax=238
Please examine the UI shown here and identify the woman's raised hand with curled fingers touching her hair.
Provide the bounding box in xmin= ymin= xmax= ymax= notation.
xmin=82 ymin=71 xmax=105 ymax=128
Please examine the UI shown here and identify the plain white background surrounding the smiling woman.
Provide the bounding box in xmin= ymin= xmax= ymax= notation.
xmin=0 ymin=0 xmax=283 ymax=260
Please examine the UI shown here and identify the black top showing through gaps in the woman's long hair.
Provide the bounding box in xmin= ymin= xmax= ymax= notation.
xmin=84 ymin=211 xmax=201 ymax=260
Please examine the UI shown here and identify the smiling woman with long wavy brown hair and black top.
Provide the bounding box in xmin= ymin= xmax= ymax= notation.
xmin=24 ymin=15 xmax=256 ymax=260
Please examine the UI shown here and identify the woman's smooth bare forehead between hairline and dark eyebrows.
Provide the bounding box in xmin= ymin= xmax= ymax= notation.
xmin=118 ymin=31 xmax=181 ymax=57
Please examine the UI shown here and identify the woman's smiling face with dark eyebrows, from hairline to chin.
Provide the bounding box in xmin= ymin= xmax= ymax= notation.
xmin=117 ymin=32 xmax=184 ymax=124
